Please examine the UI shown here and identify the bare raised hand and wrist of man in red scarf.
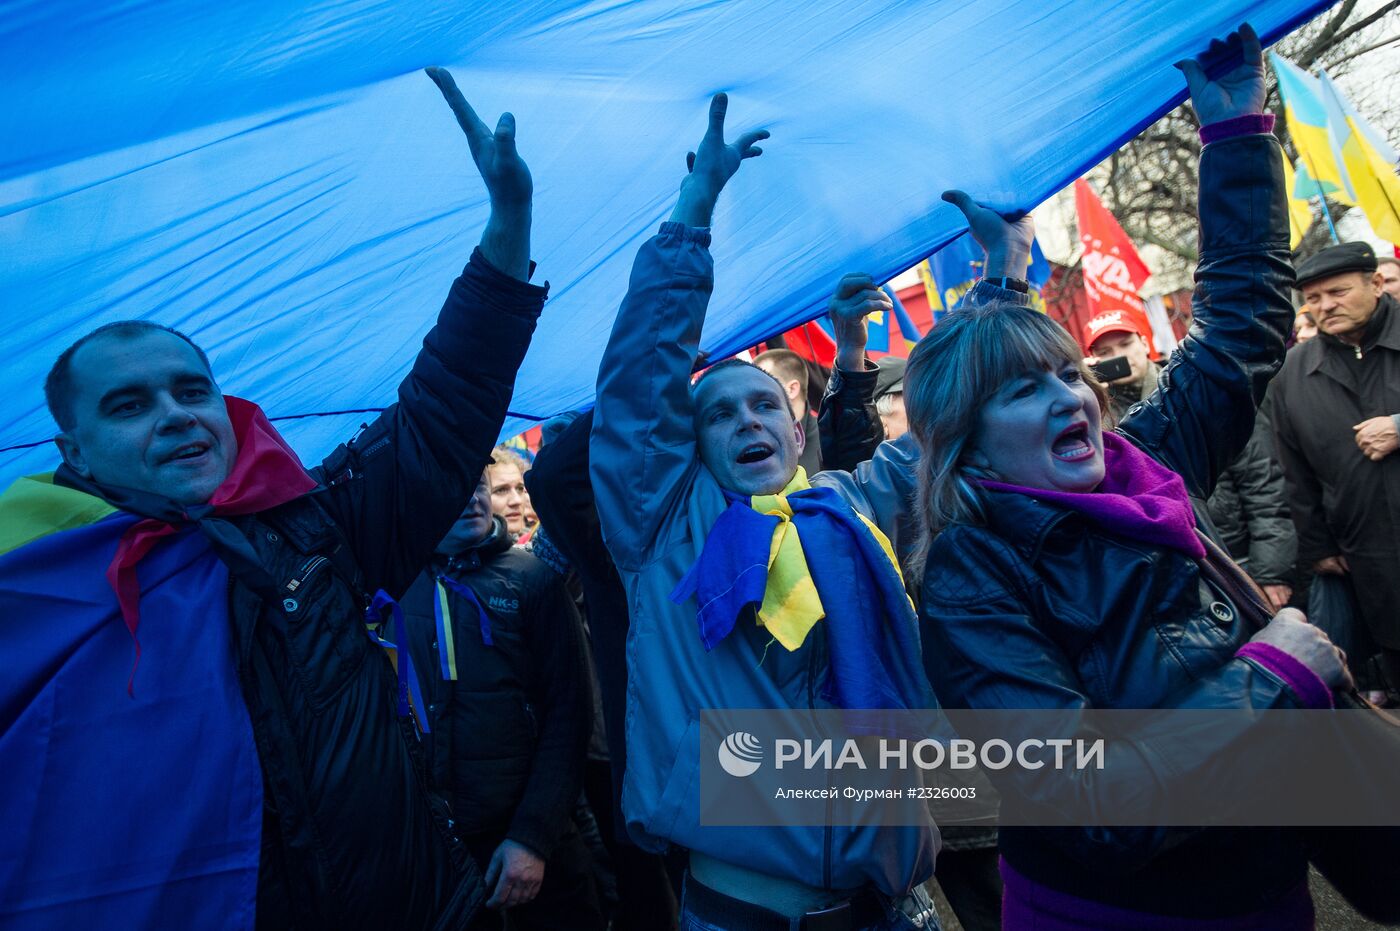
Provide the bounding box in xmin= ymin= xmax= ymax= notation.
xmin=426 ymin=67 xmax=535 ymax=281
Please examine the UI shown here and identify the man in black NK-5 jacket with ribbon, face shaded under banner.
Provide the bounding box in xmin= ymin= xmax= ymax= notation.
xmin=400 ymin=477 xmax=603 ymax=931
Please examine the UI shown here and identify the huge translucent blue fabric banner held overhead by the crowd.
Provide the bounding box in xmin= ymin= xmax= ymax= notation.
xmin=0 ymin=0 xmax=1330 ymax=486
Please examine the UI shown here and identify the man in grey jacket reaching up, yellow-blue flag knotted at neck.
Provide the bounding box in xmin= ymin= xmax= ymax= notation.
xmin=591 ymin=95 xmax=938 ymax=928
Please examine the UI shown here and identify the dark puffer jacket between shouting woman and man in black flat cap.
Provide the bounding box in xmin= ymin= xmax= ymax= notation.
xmin=1205 ymin=407 xmax=1298 ymax=585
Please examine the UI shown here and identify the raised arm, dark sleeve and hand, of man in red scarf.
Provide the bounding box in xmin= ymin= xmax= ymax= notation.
xmin=318 ymin=69 xmax=546 ymax=596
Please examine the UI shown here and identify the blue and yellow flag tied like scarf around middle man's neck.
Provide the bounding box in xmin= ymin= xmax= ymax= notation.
xmin=671 ymin=468 xmax=932 ymax=708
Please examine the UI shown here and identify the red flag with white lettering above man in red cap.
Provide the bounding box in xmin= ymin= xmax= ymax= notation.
xmin=1074 ymin=178 xmax=1158 ymax=356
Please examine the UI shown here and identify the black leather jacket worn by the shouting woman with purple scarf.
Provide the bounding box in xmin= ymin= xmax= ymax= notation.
xmin=921 ymin=136 xmax=1306 ymax=916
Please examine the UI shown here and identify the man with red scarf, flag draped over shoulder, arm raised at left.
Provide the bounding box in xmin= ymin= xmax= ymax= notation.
xmin=0 ymin=70 xmax=545 ymax=930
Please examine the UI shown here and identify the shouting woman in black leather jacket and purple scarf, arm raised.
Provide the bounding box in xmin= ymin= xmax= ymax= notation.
xmin=904 ymin=25 xmax=1345 ymax=930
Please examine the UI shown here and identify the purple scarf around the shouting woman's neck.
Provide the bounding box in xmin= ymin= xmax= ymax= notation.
xmin=981 ymin=433 xmax=1205 ymax=560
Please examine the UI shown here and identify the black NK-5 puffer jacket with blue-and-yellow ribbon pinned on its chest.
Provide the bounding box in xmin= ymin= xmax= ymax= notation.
xmin=402 ymin=518 xmax=594 ymax=858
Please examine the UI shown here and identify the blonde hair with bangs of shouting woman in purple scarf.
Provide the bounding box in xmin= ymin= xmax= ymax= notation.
xmin=904 ymin=301 xmax=1109 ymax=573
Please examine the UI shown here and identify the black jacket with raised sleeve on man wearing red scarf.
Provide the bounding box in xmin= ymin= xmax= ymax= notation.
xmin=218 ymin=253 xmax=545 ymax=931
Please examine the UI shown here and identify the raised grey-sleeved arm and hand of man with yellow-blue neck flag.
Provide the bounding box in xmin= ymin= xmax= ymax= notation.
xmin=589 ymin=94 xmax=767 ymax=568
